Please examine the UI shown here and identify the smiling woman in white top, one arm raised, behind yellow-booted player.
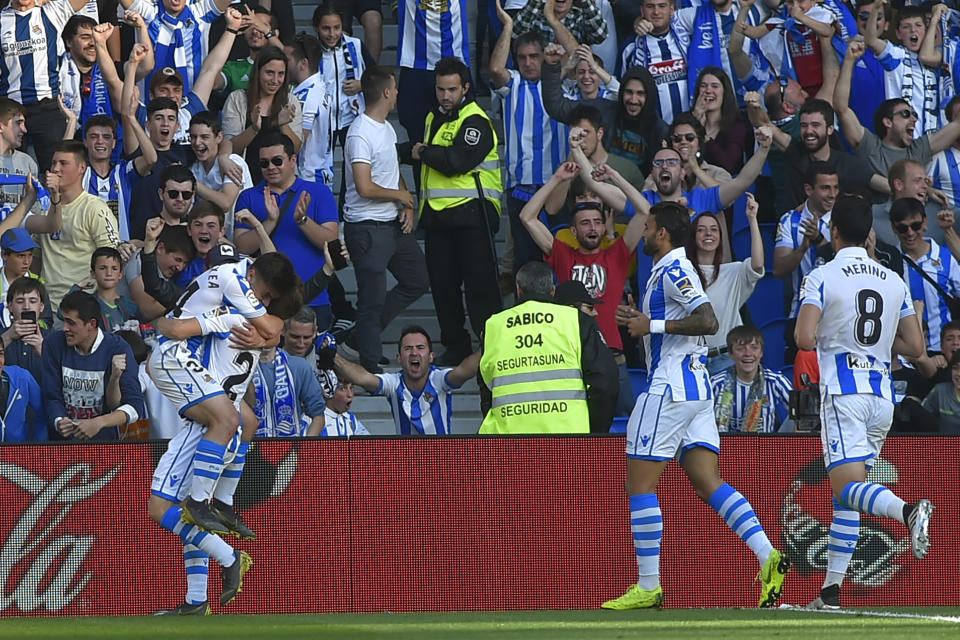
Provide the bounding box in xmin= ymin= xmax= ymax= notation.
xmin=686 ymin=193 xmax=764 ymax=375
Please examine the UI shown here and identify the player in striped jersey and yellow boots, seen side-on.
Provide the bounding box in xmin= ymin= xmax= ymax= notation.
xmin=603 ymin=202 xmax=790 ymax=609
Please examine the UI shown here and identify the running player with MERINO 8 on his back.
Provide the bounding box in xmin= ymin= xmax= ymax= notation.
xmin=796 ymin=196 xmax=933 ymax=609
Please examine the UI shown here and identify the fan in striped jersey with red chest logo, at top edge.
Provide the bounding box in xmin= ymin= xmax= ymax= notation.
xmin=620 ymin=0 xmax=691 ymax=122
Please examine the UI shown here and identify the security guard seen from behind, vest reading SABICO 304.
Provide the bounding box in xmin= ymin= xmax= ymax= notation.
xmin=480 ymin=262 xmax=619 ymax=434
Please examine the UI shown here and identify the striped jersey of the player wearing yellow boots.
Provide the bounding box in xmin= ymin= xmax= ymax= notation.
xmin=640 ymin=247 xmax=711 ymax=402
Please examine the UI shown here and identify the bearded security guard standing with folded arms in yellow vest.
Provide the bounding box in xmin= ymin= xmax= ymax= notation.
xmin=399 ymin=57 xmax=503 ymax=366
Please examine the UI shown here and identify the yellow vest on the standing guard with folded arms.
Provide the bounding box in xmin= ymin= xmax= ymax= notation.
xmin=420 ymin=102 xmax=503 ymax=215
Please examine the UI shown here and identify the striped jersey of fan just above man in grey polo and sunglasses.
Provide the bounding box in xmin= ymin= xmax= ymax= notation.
xmin=877 ymin=42 xmax=943 ymax=139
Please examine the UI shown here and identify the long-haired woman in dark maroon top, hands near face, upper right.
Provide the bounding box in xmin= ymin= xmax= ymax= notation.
xmin=691 ymin=67 xmax=751 ymax=173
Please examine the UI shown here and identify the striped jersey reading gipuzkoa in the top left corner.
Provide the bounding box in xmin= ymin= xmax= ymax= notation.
xmin=0 ymin=0 xmax=75 ymax=104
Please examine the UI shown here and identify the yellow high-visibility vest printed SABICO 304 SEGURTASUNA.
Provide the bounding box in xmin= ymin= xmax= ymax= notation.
xmin=480 ymin=300 xmax=590 ymax=434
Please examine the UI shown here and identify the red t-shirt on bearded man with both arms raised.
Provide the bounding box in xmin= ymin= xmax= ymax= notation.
xmin=546 ymin=238 xmax=633 ymax=351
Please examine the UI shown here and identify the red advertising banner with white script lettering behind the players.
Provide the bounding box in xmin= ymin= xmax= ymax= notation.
xmin=0 ymin=437 xmax=960 ymax=616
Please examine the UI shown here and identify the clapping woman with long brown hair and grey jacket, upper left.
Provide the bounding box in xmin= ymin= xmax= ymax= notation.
xmin=223 ymin=45 xmax=303 ymax=183
